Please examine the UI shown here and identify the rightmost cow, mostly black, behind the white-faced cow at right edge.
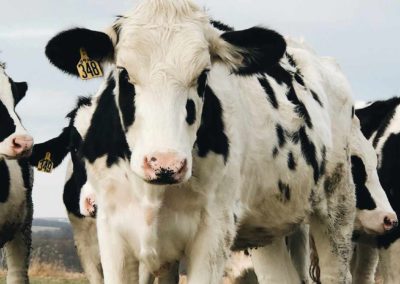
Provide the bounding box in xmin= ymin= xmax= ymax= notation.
xmin=356 ymin=97 xmax=400 ymax=283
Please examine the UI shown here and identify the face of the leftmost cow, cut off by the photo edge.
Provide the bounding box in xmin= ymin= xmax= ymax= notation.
xmin=0 ymin=64 xmax=33 ymax=159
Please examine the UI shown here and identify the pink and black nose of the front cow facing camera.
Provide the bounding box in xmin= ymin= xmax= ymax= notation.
xmin=143 ymin=152 xmax=187 ymax=184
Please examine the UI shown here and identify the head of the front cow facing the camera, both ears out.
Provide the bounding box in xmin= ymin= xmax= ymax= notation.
xmin=46 ymin=0 xmax=286 ymax=184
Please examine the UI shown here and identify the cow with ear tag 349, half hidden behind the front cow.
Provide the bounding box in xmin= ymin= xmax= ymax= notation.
xmin=29 ymin=97 xmax=178 ymax=284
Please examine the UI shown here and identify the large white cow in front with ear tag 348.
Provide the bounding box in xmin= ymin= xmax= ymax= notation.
xmin=46 ymin=0 xmax=355 ymax=284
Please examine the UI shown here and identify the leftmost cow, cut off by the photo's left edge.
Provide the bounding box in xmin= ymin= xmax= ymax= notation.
xmin=0 ymin=64 xmax=33 ymax=283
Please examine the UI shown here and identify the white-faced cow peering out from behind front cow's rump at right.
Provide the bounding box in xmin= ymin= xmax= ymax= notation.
xmin=304 ymin=117 xmax=398 ymax=283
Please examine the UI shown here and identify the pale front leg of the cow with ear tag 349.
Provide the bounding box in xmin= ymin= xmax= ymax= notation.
xmin=68 ymin=214 xmax=104 ymax=284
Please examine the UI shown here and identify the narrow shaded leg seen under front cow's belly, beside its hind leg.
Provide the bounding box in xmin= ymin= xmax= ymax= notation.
xmin=288 ymin=224 xmax=310 ymax=284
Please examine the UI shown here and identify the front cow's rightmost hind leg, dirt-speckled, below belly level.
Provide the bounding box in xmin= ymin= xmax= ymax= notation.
xmin=310 ymin=211 xmax=354 ymax=284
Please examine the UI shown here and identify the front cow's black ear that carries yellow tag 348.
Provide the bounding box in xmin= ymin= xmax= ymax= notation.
xmin=46 ymin=28 xmax=114 ymax=76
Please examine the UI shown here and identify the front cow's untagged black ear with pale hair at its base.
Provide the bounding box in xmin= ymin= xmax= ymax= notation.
xmin=210 ymin=27 xmax=286 ymax=75
